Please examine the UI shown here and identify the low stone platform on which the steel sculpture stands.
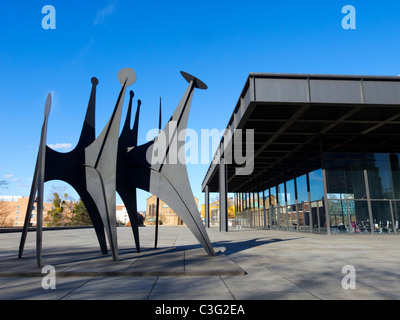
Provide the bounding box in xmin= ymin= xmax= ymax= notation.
xmin=0 ymin=228 xmax=245 ymax=277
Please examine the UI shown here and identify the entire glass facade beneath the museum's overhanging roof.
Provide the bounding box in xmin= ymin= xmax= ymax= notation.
xmin=237 ymin=153 xmax=400 ymax=234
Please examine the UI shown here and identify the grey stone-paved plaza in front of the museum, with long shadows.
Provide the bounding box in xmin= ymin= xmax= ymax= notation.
xmin=0 ymin=226 xmax=400 ymax=300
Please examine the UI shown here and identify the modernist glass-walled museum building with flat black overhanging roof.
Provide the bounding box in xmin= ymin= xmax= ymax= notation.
xmin=202 ymin=73 xmax=400 ymax=234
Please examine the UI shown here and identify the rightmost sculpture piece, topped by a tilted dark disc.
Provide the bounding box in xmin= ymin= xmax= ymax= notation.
xmin=126 ymin=73 xmax=215 ymax=256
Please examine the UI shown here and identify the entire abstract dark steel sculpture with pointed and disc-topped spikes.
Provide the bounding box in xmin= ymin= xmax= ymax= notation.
xmin=19 ymin=68 xmax=215 ymax=266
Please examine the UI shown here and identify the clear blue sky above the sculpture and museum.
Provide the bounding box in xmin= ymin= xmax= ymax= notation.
xmin=0 ymin=0 xmax=400 ymax=210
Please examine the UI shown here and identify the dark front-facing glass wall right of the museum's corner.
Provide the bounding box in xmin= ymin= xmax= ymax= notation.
xmin=324 ymin=153 xmax=400 ymax=233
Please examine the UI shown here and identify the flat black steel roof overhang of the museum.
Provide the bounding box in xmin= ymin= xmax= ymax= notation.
xmin=202 ymin=73 xmax=400 ymax=192
